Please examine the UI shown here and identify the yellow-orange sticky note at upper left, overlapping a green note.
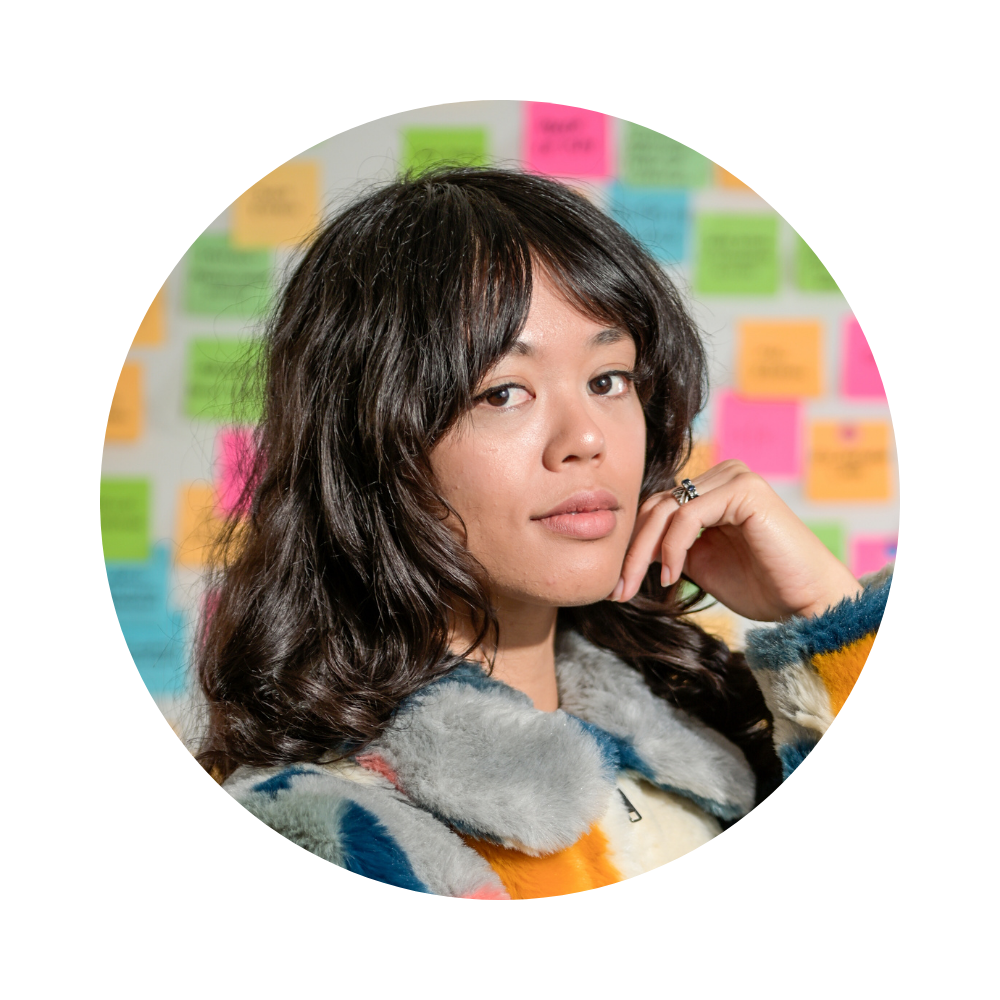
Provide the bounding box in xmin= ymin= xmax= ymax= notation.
xmin=230 ymin=160 xmax=319 ymax=250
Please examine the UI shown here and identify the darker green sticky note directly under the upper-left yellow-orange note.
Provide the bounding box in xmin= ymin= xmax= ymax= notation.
xmin=184 ymin=233 xmax=274 ymax=319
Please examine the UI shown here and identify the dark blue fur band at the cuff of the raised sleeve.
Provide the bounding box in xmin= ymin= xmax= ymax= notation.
xmin=746 ymin=576 xmax=892 ymax=670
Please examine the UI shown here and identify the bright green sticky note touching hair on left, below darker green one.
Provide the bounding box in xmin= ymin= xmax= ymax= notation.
xmin=184 ymin=337 xmax=262 ymax=424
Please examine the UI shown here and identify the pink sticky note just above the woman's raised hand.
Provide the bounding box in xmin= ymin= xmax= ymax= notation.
xmin=716 ymin=391 xmax=802 ymax=478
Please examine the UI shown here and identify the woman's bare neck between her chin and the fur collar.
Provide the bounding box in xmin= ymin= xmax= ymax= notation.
xmin=450 ymin=598 xmax=559 ymax=712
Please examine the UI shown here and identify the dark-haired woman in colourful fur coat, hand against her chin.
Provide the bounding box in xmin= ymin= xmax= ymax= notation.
xmin=198 ymin=170 xmax=891 ymax=899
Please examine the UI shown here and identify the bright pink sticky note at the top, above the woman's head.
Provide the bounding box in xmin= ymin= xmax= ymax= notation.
xmin=524 ymin=101 xmax=611 ymax=177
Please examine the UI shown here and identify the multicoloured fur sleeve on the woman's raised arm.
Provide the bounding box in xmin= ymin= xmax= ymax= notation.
xmin=746 ymin=563 xmax=895 ymax=778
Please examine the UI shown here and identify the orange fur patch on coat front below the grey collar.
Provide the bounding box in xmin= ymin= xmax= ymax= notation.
xmin=463 ymin=826 xmax=622 ymax=899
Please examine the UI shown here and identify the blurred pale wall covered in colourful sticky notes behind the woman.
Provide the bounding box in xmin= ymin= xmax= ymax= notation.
xmin=101 ymin=101 xmax=899 ymax=745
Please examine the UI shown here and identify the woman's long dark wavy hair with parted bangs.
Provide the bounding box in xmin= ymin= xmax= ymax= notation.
xmin=196 ymin=169 xmax=780 ymax=801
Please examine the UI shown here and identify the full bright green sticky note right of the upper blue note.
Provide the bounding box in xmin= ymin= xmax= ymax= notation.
xmin=694 ymin=212 xmax=778 ymax=295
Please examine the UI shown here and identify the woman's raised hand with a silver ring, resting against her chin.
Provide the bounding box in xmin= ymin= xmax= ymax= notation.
xmin=609 ymin=460 xmax=862 ymax=621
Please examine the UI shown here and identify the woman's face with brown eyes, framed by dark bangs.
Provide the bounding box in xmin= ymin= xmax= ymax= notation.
xmin=431 ymin=268 xmax=646 ymax=607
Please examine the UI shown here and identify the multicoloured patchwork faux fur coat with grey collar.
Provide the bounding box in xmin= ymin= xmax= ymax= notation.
xmin=223 ymin=567 xmax=893 ymax=899
